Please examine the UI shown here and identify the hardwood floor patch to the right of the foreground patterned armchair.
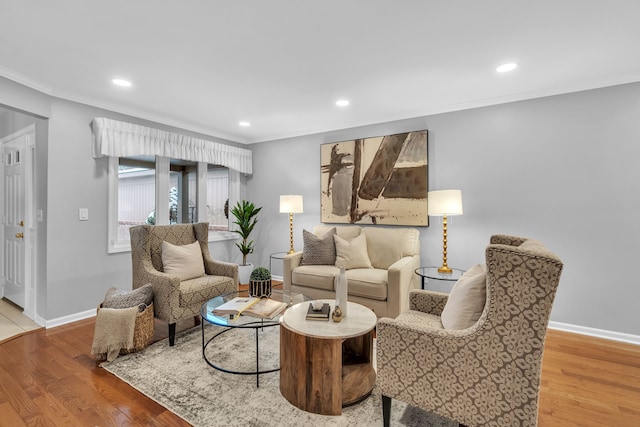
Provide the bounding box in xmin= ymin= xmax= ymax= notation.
xmin=538 ymin=330 xmax=640 ymax=427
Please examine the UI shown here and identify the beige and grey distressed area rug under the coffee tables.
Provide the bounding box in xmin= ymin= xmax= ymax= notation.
xmin=102 ymin=325 xmax=457 ymax=427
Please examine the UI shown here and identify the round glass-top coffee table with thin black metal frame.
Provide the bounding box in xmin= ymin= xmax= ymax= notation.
xmin=200 ymin=289 xmax=309 ymax=387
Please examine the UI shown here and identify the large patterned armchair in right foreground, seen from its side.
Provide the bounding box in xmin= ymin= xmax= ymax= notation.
xmin=376 ymin=235 xmax=562 ymax=427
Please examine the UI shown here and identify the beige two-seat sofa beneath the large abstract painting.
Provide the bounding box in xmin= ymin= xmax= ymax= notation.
xmin=283 ymin=225 xmax=420 ymax=317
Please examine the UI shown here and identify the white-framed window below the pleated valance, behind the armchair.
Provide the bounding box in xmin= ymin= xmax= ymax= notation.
xmin=108 ymin=156 xmax=240 ymax=253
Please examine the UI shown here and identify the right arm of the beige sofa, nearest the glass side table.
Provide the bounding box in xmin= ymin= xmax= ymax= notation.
xmin=387 ymin=255 xmax=420 ymax=317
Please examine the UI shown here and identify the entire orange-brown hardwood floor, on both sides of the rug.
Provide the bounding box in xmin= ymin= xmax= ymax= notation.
xmin=0 ymin=319 xmax=640 ymax=427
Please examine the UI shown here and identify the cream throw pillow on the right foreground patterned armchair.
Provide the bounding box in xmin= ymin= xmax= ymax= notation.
xmin=440 ymin=264 xmax=487 ymax=329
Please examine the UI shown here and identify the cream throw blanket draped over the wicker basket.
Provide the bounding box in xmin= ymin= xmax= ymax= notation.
xmin=91 ymin=307 xmax=138 ymax=362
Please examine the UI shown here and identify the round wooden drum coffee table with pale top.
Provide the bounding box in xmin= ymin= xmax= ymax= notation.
xmin=280 ymin=300 xmax=377 ymax=415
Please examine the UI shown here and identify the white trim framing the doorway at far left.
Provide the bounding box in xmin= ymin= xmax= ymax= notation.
xmin=0 ymin=123 xmax=38 ymax=321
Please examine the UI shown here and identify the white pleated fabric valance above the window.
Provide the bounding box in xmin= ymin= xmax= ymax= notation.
xmin=91 ymin=117 xmax=253 ymax=174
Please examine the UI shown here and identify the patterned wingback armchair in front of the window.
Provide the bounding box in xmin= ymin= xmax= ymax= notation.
xmin=129 ymin=222 xmax=238 ymax=346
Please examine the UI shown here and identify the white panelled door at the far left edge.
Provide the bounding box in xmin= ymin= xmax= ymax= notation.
xmin=2 ymin=128 xmax=35 ymax=308
